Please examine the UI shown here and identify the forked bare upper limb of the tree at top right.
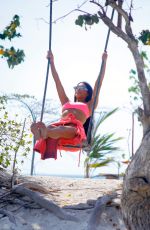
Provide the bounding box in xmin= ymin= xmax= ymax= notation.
xmin=93 ymin=0 xmax=150 ymax=116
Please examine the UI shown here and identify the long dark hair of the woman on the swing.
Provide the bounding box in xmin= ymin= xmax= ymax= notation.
xmin=74 ymin=81 xmax=93 ymax=139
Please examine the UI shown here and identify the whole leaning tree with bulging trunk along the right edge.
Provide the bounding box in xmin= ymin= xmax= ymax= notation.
xmin=76 ymin=0 xmax=150 ymax=230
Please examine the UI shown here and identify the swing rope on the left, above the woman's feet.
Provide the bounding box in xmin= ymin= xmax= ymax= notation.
xmin=40 ymin=0 xmax=52 ymax=121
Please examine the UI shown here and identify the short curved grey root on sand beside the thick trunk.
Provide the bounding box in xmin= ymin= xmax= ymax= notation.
xmin=87 ymin=193 xmax=117 ymax=230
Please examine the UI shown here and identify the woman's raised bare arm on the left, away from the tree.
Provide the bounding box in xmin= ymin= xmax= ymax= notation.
xmin=47 ymin=51 xmax=69 ymax=105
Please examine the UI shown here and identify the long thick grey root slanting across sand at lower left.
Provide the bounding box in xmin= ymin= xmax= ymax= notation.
xmin=12 ymin=185 xmax=78 ymax=221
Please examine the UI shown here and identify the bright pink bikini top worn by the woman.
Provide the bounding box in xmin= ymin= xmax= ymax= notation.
xmin=62 ymin=102 xmax=90 ymax=118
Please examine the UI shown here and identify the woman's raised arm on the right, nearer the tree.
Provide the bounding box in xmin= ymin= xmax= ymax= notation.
xmin=89 ymin=52 xmax=107 ymax=108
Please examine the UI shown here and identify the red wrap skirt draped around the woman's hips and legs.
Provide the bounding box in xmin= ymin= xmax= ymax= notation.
xmin=34 ymin=113 xmax=86 ymax=160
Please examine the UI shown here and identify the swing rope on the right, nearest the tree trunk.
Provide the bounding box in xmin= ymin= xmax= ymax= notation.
xmin=87 ymin=9 xmax=114 ymax=144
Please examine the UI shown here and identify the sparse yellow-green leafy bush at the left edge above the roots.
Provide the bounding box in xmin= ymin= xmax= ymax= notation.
xmin=0 ymin=97 xmax=31 ymax=168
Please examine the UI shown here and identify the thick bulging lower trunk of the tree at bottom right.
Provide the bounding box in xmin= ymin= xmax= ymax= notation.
xmin=121 ymin=132 xmax=150 ymax=230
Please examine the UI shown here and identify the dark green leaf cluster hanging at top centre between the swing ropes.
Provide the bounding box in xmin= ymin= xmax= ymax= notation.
xmin=75 ymin=14 xmax=99 ymax=30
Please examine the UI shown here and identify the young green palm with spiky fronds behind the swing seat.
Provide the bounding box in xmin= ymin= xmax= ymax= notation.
xmin=84 ymin=109 xmax=122 ymax=177
